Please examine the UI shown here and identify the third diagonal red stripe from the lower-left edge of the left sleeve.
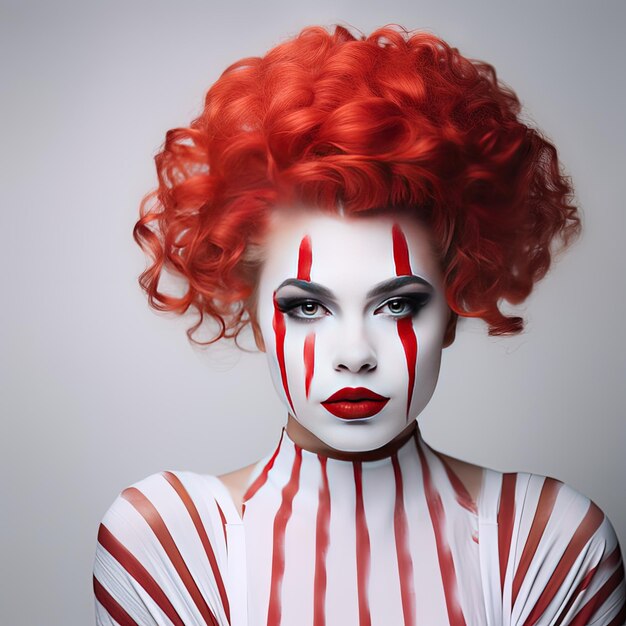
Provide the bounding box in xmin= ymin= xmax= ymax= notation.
xmin=122 ymin=487 xmax=218 ymax=626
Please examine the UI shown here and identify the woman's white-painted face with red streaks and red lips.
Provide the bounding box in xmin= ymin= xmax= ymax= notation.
xmin=257 ymin=210 xmax=450 ymax=451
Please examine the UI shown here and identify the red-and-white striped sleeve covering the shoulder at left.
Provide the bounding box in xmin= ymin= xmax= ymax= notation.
xmin=93 ymin=471 xmax=227 ymax=625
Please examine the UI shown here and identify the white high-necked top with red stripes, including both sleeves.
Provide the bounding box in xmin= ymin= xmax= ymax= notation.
xmin=94 ymin=428 xmax=626 ymax=626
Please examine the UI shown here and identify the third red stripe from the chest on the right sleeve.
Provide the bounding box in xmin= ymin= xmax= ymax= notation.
xmin=524 ymin=502 xmax=604 ymax=626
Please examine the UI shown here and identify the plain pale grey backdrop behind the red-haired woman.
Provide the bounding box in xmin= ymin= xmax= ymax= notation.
xmin=0 ymin=0 xmax=626 ymax=626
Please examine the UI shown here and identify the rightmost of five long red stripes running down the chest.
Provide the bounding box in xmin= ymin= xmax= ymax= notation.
xmin=415 ymin=438 xmax=465 ymax=626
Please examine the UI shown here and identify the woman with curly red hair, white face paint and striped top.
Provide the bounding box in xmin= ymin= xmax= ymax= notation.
xmin=94 ymin=28 xmax=626 ymax=626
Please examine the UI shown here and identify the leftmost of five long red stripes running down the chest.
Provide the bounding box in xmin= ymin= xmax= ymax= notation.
xmin=267 ymin=446 xmax=302 ymax=626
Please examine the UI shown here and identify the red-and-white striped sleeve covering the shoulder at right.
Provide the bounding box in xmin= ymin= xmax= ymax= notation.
xmin=490 ymin=472 xmax=626 ymax=624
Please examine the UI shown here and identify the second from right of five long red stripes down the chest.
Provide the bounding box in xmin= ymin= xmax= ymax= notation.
xmin=391 ymin=452 xmax=415 ymax=626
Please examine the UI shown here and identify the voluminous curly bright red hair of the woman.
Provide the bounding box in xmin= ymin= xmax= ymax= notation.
xmin=134 ymin=26 xmax=580 ymax=343
